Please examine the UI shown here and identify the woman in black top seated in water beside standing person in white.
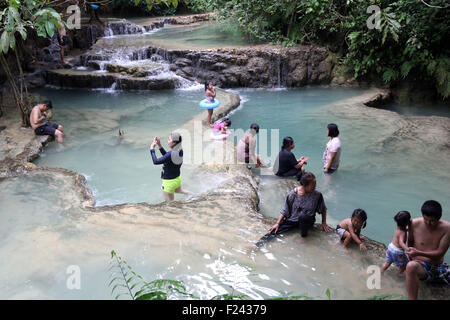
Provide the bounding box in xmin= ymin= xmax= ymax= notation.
xmin=273 ymin=137 xmax=309 ymax=181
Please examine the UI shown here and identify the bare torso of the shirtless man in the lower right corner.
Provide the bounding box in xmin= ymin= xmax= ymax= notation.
xmin=408 ymin=218 xmax=450 ymax=264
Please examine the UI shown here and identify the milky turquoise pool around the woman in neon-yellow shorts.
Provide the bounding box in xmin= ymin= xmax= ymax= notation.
xmin=35 ymin=89 xmax=221 ymax=205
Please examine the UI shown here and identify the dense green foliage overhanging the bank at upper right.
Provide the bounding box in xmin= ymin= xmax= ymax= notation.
xmin=212 ymin=0 xmax=450 ymax=98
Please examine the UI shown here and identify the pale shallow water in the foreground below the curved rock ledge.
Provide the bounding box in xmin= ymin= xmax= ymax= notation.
xmin=0 ymin=173 xmax=418 ymax=299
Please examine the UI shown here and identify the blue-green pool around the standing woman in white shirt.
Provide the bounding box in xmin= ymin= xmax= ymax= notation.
xmin=231 ymin=88 xmax=450 ymax=262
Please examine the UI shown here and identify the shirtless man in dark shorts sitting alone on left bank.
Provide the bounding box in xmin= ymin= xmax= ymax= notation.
xmin=30 ymin=100 xmax=64 ymax=143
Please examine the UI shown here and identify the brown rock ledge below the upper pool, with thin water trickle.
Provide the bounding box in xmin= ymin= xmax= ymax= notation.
xmin=141 ymin=46 xmax=332 ymax=87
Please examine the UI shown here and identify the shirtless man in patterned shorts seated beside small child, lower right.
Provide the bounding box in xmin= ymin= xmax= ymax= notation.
xmin=406 ymin=200 xmax=450 ymax=300
